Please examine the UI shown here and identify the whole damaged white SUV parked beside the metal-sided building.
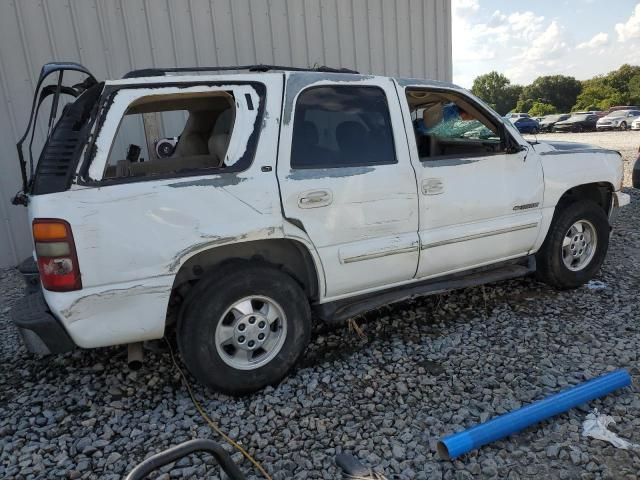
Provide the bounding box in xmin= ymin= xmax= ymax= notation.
xmin=13 ymin=64 xmax=629 ymax=394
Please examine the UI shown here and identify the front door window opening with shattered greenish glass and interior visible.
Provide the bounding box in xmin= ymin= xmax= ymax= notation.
xmin=407 ymin=89 xmax=504 ymax=161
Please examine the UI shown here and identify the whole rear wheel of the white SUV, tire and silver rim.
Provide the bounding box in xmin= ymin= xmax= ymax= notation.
xmin=177 ymin=264 xmax=311 ymax=395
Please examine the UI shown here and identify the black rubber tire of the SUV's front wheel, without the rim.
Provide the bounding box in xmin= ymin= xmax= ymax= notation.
xmin=536 ymin=200 xmax=610 ymax=289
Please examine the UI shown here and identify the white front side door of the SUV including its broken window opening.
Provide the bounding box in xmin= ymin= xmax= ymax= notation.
xmin=398 ymin=82 xmax=544 ymax=278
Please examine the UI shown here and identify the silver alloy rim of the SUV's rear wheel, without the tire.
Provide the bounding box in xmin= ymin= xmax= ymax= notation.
xmin=215 ymin=295 xmax=287 ymax=370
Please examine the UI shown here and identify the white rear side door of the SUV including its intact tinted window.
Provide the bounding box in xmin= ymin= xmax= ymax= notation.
xmin=278 ymin=73 xmax=419 ymax=298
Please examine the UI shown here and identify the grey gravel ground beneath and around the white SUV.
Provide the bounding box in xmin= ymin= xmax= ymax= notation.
xmin=0 ymin=132 xmax=640 ymax=480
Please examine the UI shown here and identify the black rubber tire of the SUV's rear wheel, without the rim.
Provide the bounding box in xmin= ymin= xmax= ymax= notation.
xmin=177 ymin=262 xmax=311 ymax=395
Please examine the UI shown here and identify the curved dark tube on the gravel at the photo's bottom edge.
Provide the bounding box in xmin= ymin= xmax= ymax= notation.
xmin=125 ymin=438 xmax=245 ymax=480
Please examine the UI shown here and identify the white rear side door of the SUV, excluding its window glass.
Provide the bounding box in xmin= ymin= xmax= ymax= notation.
xmin=278 ymin=73 xmax=418 ymax=301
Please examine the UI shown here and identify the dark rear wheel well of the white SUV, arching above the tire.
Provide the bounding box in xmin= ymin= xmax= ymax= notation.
xmin=167 ymin=239 xmax=319 ymax=324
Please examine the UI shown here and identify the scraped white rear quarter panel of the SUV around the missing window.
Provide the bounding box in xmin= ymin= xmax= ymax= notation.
xmin=30 ymin=75 xmax=284 ymax=346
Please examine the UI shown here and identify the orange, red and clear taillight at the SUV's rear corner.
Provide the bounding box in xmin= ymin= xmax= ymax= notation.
xmin=33 ymin=218 xmax=82 ymax=292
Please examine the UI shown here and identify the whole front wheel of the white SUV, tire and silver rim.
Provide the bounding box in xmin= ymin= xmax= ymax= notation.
xmin=536 ymin=201 xmax=610 ymax=289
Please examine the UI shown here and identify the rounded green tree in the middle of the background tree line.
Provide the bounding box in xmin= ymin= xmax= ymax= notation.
xmin=519 ymin=75 xmax=582 ymax=112
